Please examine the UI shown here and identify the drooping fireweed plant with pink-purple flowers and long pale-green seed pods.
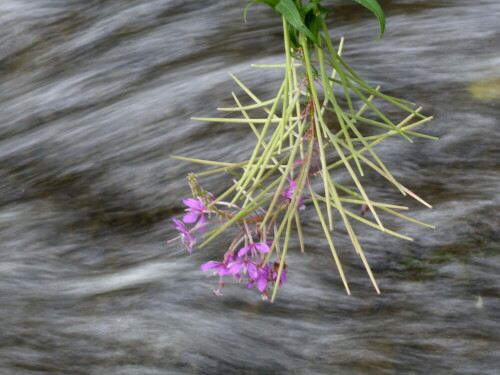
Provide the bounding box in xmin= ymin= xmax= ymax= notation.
xmin=168 ymin=0 xmax=435 ymax=302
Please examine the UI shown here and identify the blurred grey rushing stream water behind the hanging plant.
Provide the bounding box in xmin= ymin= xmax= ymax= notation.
xmin=0 ymin=0 xmax=500 ymax=375
